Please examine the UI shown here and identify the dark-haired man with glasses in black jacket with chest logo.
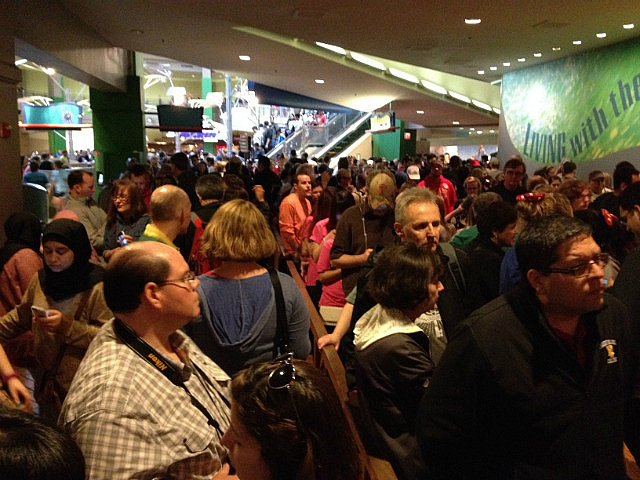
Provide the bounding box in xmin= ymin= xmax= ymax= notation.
xmin=418 ymin=216 xmax=640 ymax=480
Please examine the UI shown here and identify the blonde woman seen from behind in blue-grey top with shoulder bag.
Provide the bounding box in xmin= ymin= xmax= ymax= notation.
xmin=186 ymin=200 xmax=311 ymax=376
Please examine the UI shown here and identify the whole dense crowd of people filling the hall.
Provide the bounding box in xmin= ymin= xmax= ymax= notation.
xmin=0 ymin=144 xmax=640 ymax=480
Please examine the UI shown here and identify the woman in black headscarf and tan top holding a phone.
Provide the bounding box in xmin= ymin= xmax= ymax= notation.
xmin=0 ymin=219 xmax=113 ymax=422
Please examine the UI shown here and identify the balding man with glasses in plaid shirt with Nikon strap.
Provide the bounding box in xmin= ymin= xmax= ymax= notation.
xmin=59 ymin=242 xmax=236 ymax=480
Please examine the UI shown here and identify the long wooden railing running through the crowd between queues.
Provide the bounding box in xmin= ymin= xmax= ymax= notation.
xmin=276 ymin=234 xmax=397 ymax=480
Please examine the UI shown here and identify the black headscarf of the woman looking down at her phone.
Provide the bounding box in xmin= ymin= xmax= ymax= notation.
xmin=40 ymin=218 xmax=104 ymax=301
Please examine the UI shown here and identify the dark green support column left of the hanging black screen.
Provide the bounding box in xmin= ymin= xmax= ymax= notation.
xmin=90 ymin=75 xmax=147 ymax=183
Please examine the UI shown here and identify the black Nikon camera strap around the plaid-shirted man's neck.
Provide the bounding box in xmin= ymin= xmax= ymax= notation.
xmin=113 ymin=318 xmax=226 ymax=436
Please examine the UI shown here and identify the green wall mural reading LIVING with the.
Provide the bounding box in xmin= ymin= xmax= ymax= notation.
xmin=502 ymin=39 xmax=640 ymax=163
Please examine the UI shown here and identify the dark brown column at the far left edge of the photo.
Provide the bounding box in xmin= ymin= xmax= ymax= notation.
xmin=0 ymin=2 xmax=22 ymax=243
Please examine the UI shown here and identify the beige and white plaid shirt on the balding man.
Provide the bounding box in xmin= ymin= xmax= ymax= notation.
xmin=59 ymin=321 xmax=229 ymax=480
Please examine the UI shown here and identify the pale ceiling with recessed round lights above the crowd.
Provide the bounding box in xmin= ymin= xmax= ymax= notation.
xmin=13 ymin=0 xmax=640 ymax=137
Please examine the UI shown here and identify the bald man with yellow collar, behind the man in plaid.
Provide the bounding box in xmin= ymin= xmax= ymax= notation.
xmin=140 ymin=185 xmax=191 ymax=250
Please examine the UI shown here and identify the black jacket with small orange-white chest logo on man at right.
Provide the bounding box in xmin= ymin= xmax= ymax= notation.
xmin=417 ymin=285 xmax=640 ymax=480
